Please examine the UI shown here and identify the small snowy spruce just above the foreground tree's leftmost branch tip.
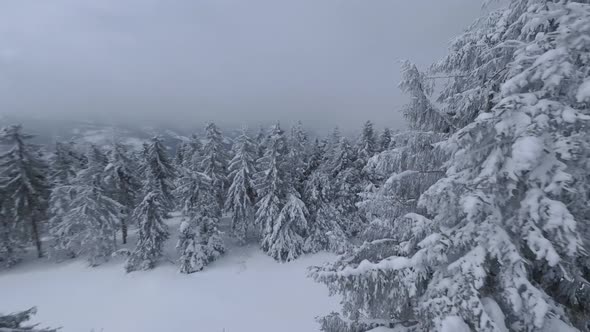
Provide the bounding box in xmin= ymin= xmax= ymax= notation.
xmin=304 ymin=170 xmax=350 ymax=254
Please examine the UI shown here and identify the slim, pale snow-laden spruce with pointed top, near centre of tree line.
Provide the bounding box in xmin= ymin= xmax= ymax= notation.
xmin=225 ymin=129 xmax=256 ymax=243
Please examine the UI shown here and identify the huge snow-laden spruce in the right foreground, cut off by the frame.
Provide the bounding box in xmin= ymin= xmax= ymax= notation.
xmin=315 ymin=0 xmax=590 ymax=331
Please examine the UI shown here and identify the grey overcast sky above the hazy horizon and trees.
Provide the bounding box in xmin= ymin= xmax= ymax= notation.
xmin=0 ymin=0 xmax=481 ymax=129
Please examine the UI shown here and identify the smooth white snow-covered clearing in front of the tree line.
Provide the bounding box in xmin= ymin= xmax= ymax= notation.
xmin=0 ymin=218 xmax=338 ymax=332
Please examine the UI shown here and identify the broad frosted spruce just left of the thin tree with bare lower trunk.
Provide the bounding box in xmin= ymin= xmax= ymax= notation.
xmin=51 ymin=146 xmax=123 ymax=266
